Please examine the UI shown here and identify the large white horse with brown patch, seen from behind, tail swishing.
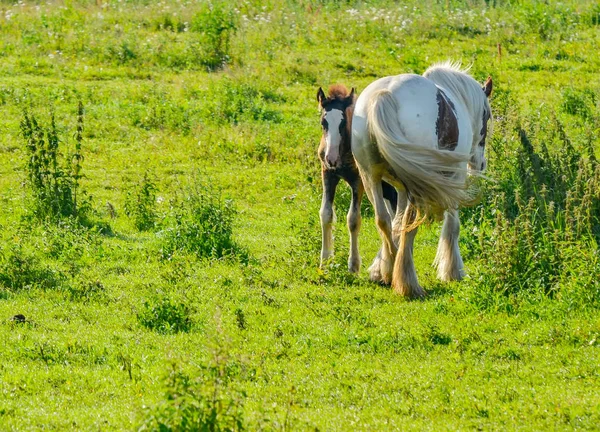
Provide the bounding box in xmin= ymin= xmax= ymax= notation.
xmin=352 ymin=62 xmax=493 ymax=298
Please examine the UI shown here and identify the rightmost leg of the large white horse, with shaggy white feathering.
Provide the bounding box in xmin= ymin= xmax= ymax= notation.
xmin=433 ymin=210 xmax=464 ymax=281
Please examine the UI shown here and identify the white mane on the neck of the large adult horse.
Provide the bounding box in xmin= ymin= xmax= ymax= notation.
xmin=423 ymin=61 xmax=491 ymax=128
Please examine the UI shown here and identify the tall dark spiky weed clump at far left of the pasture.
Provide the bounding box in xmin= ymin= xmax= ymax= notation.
xmin=21 ymin=102 xmax=89 ymax=220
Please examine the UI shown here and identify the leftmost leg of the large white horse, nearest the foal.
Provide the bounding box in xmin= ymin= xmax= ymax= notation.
xmin=363 ymin=178 xmax=397 ymax=284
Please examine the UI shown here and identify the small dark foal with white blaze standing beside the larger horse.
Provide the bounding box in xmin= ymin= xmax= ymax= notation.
xmin=317 ymin=84 xmax=397 ymax=273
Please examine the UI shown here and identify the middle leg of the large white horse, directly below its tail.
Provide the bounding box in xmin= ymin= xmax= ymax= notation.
xmin=392 ymin=204 xmax=425 ymax=298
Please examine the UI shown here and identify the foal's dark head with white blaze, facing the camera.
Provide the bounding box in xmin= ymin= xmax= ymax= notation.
xmin=317 ymin=84 xmax=355 ymax=168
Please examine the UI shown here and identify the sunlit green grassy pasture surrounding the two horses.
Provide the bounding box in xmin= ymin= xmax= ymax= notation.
xmin=0 ymin=0 xmax=600 ymax=431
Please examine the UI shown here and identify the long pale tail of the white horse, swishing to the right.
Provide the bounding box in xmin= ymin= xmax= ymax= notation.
xmin=367 ymin=89 xmax=474 ymax=226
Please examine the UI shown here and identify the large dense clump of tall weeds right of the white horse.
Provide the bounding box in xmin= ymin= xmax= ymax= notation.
xmin=465 ymin=104 xmax=600 ymax=303
